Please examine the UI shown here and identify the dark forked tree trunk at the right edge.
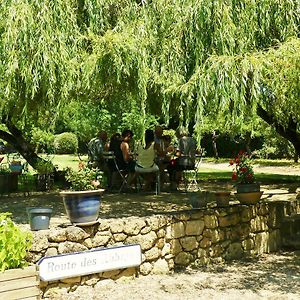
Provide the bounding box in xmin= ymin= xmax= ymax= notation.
xmin=257 ymin=105 xmax=300 ymax=162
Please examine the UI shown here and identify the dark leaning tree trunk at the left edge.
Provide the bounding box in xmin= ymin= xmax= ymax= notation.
xmin=0 ymin=118 xmax=44 ymax=169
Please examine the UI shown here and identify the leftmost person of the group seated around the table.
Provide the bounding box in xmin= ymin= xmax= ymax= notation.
xmin=88 ymin=130 xmax=107 ymax=169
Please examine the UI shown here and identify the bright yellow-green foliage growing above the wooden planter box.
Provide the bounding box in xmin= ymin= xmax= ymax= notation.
xmin=0 ymin=213 xmax=32 ymax=272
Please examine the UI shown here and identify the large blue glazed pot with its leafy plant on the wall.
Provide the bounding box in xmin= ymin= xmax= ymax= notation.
xmin=60 ymin=163 xmax=104 ymax=225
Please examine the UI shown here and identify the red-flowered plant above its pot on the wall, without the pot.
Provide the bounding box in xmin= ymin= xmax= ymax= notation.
xmin=229 ymin=150 xmax=254 ymax=184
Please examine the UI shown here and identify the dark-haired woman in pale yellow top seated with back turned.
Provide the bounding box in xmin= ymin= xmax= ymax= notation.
xmin=135 ymin=129 xmax=159 ymax=190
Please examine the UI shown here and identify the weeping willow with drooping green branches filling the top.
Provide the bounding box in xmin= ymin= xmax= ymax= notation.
xmin=0 ymin=0 xmax=300 ymax=163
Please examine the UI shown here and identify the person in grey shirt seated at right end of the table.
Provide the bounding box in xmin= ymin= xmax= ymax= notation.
xmin=167 ymin=128 xmax=197 ymax=190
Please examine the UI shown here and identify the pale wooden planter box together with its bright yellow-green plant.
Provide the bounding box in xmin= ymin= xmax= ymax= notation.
xmin=0 ymin=213 xmax=40 ymax=299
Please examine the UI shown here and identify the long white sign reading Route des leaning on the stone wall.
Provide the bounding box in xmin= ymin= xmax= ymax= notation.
xmin=38 ymin=245 xmax=142 ymax=281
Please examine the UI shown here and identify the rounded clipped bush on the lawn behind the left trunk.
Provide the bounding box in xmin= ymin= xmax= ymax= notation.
xmin=54 ymin=132 xmax=78 ymax=154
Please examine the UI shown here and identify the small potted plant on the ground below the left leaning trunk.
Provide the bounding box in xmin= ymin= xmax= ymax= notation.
xmin=36 ymin=160 xmax=54 ymax=191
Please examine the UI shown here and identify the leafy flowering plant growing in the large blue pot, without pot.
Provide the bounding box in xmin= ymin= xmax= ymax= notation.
xmin=66 ymin=162 xmax=103 ymax=191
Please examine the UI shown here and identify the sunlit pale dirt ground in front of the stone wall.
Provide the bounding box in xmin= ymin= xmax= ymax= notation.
xmin=54 ymin=252 xmax=300 ymax=300
